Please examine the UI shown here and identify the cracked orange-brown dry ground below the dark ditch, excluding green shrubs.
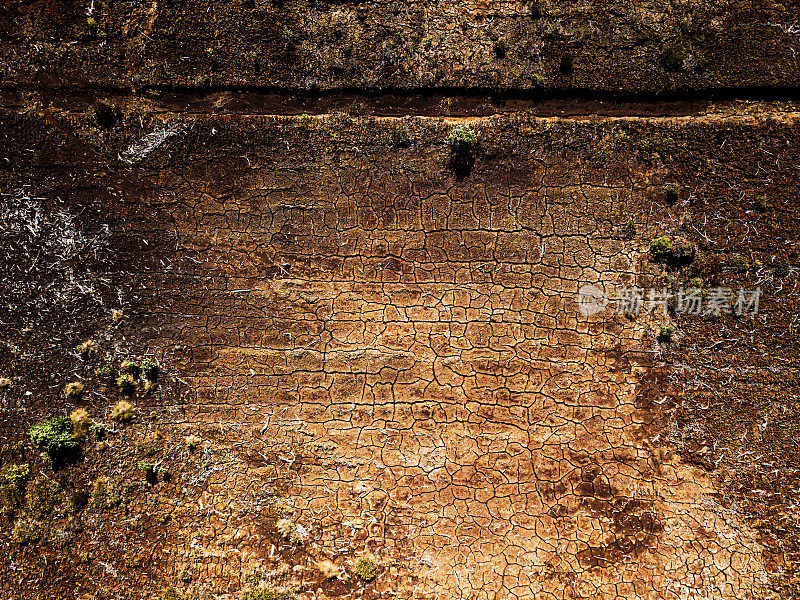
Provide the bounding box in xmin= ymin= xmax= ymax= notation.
xmin=0 ymin=100 xmax=800 ymax=599
